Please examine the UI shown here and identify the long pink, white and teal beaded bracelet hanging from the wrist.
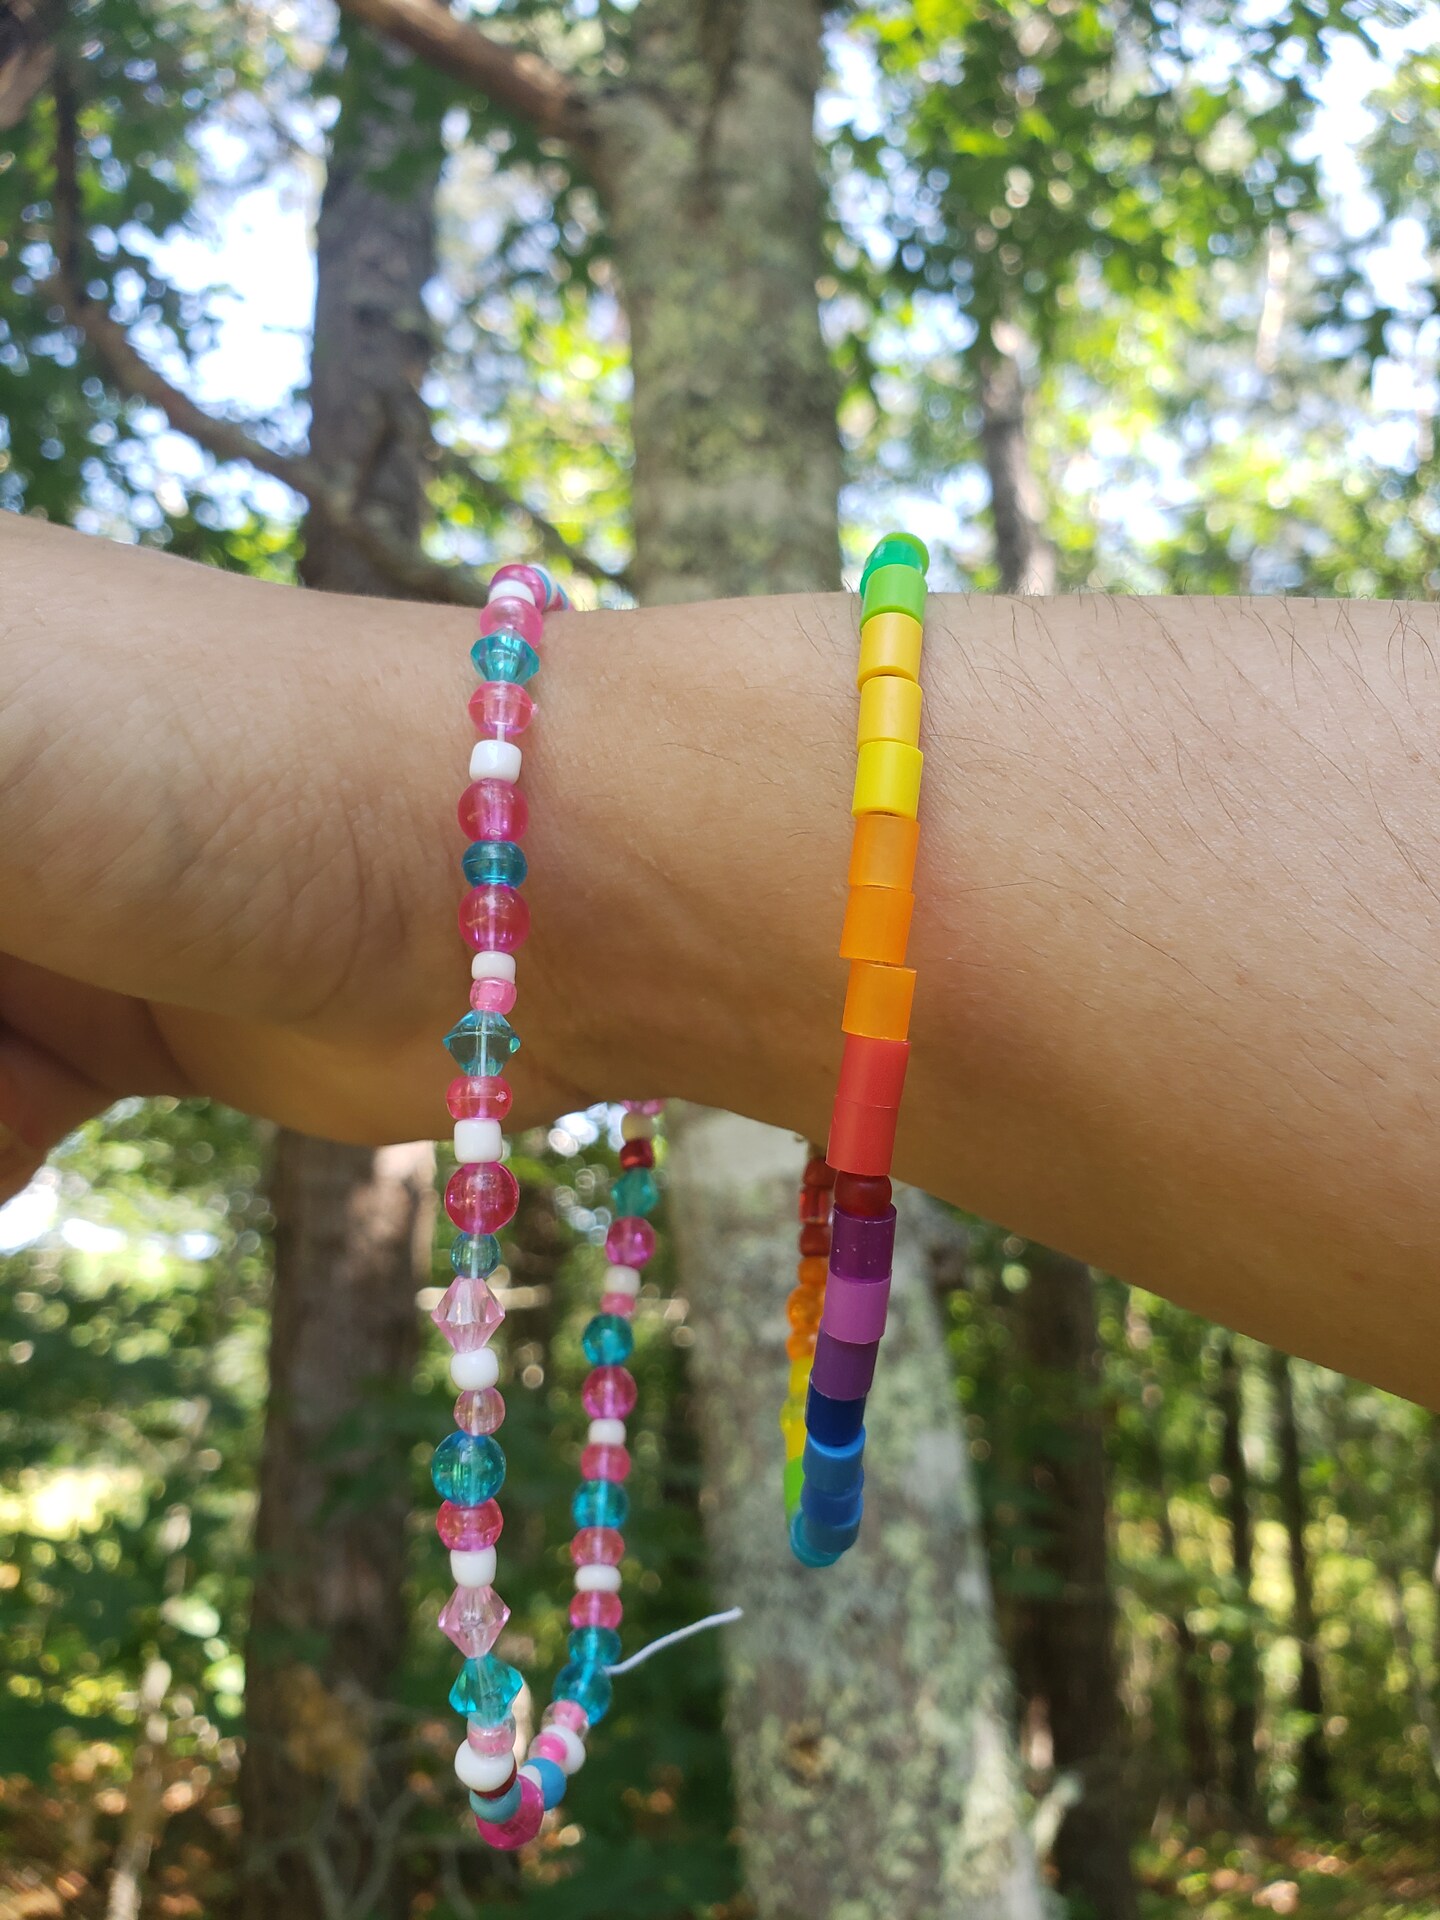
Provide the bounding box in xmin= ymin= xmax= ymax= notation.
xmin=430 ymin=566 xmax=660 ymax=1851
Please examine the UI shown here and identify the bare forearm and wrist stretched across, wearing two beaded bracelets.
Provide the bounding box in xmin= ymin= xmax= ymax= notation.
xmin=0 ymin=515 xmax=1440 ymax=1405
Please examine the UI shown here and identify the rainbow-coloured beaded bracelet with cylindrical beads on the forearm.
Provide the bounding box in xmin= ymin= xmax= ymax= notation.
xmin=780 ymin=534 xmax=929 ymax=1567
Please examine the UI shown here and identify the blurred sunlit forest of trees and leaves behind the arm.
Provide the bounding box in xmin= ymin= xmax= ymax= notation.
xmin=0 ymin=0 xmax=1440 ymax=1920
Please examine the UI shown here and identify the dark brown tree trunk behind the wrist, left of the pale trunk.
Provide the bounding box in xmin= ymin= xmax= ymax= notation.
xmin=240 ymin=31 xmax=440 ymax=1920
